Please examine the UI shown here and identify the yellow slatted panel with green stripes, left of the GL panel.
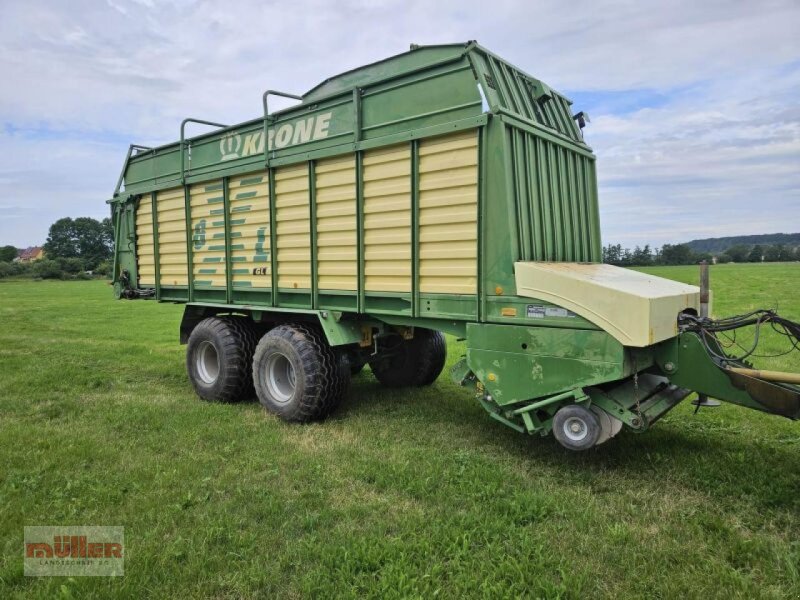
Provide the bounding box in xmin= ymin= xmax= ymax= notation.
xmin=189 ymin=180 xmax=227 ymax=288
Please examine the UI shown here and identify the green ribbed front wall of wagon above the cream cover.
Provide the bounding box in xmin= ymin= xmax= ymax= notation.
xmin=481 ymin=117 xmax=601 ymax=300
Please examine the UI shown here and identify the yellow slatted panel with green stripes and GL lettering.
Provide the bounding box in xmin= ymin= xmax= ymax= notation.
xmin=228 ymin=172 xmax=272 ymax=289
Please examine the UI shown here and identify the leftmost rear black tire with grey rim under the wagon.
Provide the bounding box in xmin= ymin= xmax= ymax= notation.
xmin=186 ymin=317 xmax=258 ymax=402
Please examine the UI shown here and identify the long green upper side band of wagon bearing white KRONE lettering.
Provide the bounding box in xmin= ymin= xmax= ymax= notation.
xmin=124 ymin=51 xmax=481 ymax=191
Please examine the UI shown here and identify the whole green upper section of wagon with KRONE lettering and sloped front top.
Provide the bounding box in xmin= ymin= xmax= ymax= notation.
xmin=114 ymin=42 xmax=588 ymax=196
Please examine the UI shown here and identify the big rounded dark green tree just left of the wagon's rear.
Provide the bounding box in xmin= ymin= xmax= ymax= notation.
xmin=44 ymin=217 xmax=113 ymax=269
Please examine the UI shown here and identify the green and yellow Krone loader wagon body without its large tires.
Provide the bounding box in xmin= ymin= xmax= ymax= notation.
xmin=110 ymin=42 xmax=797 ymax=448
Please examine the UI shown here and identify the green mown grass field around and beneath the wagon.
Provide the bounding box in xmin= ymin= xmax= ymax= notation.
xmin=0 ymin=264 xmax=800 ymax=599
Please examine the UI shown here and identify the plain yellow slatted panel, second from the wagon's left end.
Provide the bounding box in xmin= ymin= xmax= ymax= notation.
xmin=156 ymin=188 xmax=189 ymax=286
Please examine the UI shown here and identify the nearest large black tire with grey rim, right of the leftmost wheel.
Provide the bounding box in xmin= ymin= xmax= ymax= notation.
xmin=253 ymin=324 xmax=350 ymax=423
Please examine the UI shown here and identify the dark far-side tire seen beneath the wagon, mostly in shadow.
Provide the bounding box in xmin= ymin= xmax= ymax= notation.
xmin=369 ymin=328 xmax=447 ymax=387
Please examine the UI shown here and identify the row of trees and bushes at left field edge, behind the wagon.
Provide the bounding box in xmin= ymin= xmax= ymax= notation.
xmin=0 ymin=217 xmax=114 ymax=279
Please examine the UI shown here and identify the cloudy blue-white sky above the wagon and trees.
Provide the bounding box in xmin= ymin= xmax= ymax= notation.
xmin=0 ymin=0 xmax=800 ymax=246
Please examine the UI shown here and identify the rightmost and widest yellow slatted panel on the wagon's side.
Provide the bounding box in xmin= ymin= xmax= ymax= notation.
xmin=419 ymin=130 xmax=478 ymax=294
